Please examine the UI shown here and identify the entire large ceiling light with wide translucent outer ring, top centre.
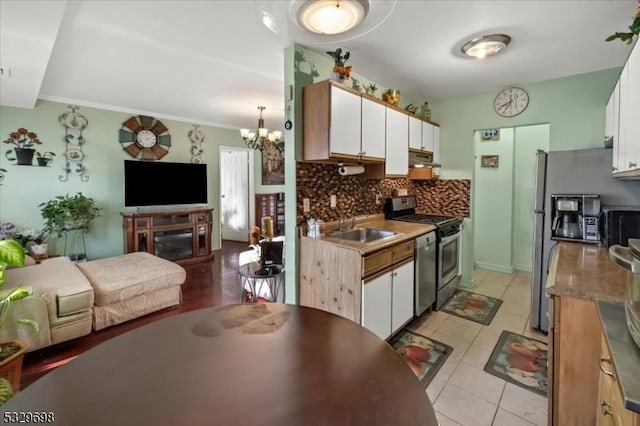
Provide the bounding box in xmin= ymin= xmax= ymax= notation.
xmin=255 ymin=0 xmax=398 ymax=46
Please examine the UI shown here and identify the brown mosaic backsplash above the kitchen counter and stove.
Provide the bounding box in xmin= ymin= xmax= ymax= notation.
xmin=296 ymin=163 xmax=471 ymax=223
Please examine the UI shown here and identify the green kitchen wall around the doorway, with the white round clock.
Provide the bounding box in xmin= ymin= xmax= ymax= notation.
xmin=432 ymin=68 xmax=620 ymax=285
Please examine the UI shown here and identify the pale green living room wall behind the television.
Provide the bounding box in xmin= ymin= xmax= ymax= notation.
xmin=0 ymin=100 xmax=245 ymax=258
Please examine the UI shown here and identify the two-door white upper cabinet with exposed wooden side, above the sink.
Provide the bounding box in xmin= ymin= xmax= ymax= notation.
xmin=302 ymin=80 xmax=385 ymax=163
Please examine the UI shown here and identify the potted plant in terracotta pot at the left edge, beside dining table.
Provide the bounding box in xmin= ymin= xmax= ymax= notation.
xmin=0 ymin=240 xmax=40 ymax=405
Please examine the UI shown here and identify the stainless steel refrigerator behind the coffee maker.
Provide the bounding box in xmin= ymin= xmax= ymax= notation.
xmin=531 ymin=148 xmax=640 ymax=331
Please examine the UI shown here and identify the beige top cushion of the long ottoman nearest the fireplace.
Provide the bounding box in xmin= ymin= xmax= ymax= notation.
xmin=76 ymin=252 xmax=187 ymax=306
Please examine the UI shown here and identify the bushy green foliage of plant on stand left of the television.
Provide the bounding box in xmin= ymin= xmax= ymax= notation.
xmin=39 ymin=192 xmax=102 ymax=237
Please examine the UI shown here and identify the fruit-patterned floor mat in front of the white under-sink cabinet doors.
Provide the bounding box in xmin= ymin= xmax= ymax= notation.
xmin=389 ymin=329 xmax=453 ymax=388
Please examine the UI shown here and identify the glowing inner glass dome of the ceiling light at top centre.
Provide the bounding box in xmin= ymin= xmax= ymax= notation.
xmin=298 ymin=0 xmax=369 ymax=35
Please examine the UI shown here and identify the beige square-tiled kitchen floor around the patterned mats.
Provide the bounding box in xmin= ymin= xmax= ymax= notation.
xmin=415 ymin=269 xmax=547 ymax=426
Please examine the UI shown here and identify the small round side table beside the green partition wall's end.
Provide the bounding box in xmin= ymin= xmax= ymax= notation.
xmin=239 ymin=262 xmax=284 ymax=303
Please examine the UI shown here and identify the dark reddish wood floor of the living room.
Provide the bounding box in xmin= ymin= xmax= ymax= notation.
xmin=21 ymin=241 xmax=247 ymax=389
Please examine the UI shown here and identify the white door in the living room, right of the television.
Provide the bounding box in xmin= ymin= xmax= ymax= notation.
xmin=220 ymin=146 xmax=253 ymax=241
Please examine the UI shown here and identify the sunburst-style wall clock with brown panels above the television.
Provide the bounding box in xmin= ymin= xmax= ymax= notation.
xmin=118 ymin=115 xmax=171 ymax=160
